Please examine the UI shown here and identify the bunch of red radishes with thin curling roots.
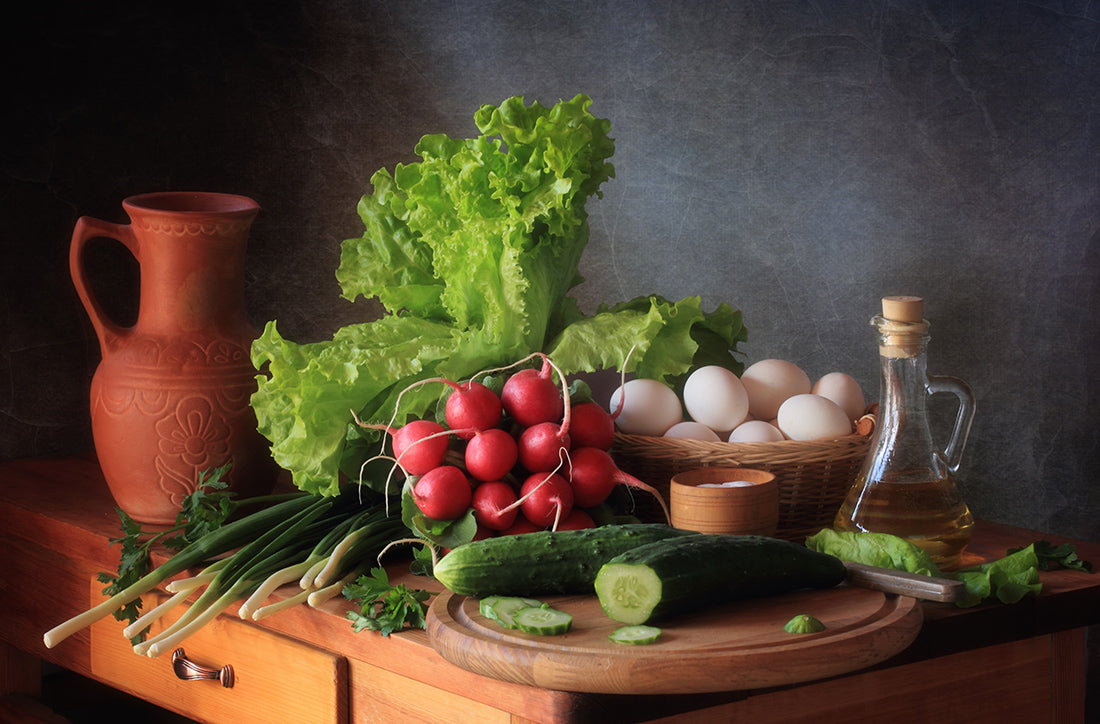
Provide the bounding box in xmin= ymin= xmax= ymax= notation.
xmin=365 ymin=354 xmax=667 ymax=536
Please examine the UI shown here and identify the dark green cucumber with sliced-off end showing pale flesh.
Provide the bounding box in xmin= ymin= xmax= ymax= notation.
xmin=595 ymin=534 xmax=845 ymax=624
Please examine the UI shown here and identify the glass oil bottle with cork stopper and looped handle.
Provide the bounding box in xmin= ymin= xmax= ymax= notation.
xmin=834 ymin=297 xmax=975 ymax=570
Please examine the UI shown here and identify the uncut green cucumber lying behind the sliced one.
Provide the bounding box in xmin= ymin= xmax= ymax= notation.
xmin=432 ymin=523 xmax=702 ymax=599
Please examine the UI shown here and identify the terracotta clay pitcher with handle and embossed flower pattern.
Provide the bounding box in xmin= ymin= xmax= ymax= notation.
xmin=69 ymin=191 xmax=277 ymax=524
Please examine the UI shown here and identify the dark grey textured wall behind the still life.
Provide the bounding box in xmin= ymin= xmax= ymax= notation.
xmin=0 ymin=0 xmax=1100 ymax=540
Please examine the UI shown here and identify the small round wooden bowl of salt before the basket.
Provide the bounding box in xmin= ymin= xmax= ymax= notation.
xmin=669 ymin=468 xmax=779 ymax=536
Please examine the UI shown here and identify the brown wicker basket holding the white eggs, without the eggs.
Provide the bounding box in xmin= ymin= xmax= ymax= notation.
xmin=612 ymin=409 xmax=876 ymax=541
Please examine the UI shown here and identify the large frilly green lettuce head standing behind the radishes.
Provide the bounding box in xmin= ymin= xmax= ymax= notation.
xmin=252 ymin=95 xmax=746 ymax=495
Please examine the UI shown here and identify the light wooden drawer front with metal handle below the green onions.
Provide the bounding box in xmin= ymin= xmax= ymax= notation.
xmin=91 ymin=581 xmax=348 ymax=724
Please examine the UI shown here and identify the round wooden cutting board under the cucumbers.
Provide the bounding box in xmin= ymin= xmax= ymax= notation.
xmin=427 ymin=585 xmax=922 ymax=694
